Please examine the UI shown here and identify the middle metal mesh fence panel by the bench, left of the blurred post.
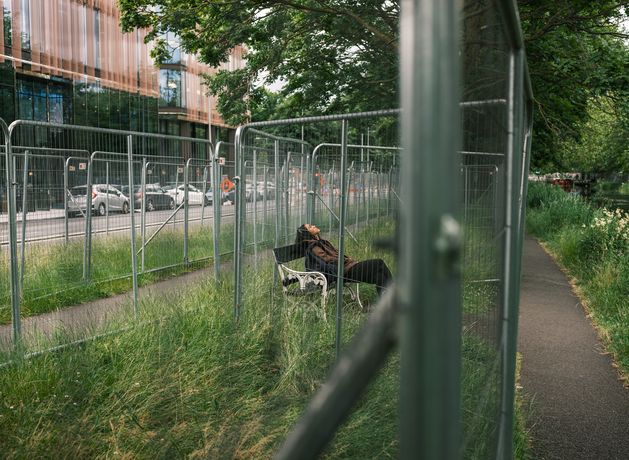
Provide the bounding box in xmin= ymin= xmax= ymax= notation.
xmin=234 ymin=110 xmax=401 ymax=334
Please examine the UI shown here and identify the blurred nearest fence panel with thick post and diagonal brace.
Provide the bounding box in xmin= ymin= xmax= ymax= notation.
xmin=272 ymin=0 xmax=532 ymax=459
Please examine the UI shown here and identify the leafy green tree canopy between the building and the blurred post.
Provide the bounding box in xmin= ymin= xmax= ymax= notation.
xmin=119 ymin=0 xmax=399 ymax=124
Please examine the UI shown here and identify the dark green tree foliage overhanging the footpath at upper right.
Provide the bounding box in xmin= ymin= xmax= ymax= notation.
xmin=518 ymin=0 xmax=629 ymax=171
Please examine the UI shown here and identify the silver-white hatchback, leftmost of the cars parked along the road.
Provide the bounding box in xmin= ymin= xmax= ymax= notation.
xmin=66 ymin=184 xmax=129 ymax=216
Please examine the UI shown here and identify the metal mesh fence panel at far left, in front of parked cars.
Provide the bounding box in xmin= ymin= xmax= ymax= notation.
xmin=0 ymin=120 xmax=251 ymax=351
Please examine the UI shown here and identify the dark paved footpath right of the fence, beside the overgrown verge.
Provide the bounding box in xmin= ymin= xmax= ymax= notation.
xmin=518 ymin=237 xmax=629 ymax=460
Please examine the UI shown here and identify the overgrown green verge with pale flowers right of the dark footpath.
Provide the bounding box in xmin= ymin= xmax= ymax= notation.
xmin=527 ymin=183 xmax=629 ymax=381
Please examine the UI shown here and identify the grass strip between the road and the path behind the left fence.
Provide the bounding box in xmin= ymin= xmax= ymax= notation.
xmin=0 ymin=226 xmax=238 ymax=324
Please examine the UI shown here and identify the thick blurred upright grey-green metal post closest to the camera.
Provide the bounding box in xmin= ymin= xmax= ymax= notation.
xmin=397 ymin=0 xmax=462 ymax=459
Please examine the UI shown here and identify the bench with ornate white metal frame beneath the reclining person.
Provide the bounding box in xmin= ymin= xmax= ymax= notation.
xmin=273 ymin=244 xmax=363 ymax=321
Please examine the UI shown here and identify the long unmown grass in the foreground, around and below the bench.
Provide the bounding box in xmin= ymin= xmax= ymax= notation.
xmin=0 ymin=217 xmax=526 ymax=459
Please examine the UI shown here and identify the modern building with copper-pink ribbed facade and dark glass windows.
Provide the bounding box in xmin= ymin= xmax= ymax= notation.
xmin=0 ymin=0 xmax=243 ymax=139
